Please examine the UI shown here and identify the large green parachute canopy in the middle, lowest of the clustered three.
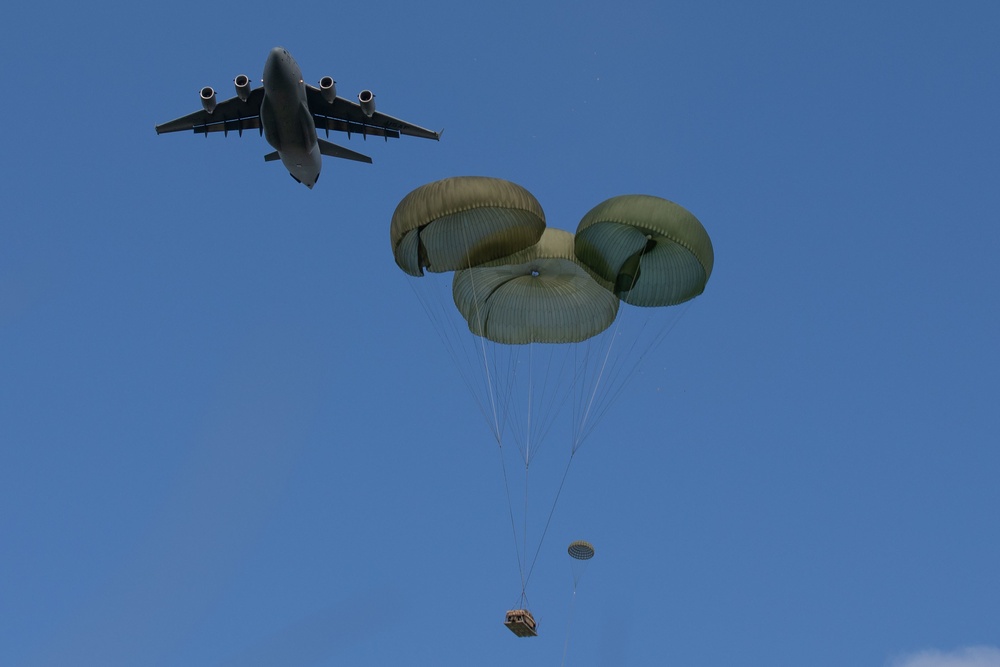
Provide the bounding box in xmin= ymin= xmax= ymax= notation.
xmin=452 ymin=228 xmax=618 ymax=345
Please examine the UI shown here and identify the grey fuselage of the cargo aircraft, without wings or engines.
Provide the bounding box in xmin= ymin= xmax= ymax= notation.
xmin=260 ymin=46 xmax=323 ymax=188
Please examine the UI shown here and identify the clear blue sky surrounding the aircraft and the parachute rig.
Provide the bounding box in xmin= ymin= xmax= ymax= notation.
xmin=0 ymin=0 xmax=1000 ymax=667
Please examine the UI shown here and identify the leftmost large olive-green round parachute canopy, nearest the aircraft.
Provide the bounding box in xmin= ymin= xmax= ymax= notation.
xmin=389 ymin=176 xmax=545 ymax=276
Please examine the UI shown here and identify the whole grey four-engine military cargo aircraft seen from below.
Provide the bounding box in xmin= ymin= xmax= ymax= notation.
xmin=156 ymin=46 xmax=441 ymax=189
